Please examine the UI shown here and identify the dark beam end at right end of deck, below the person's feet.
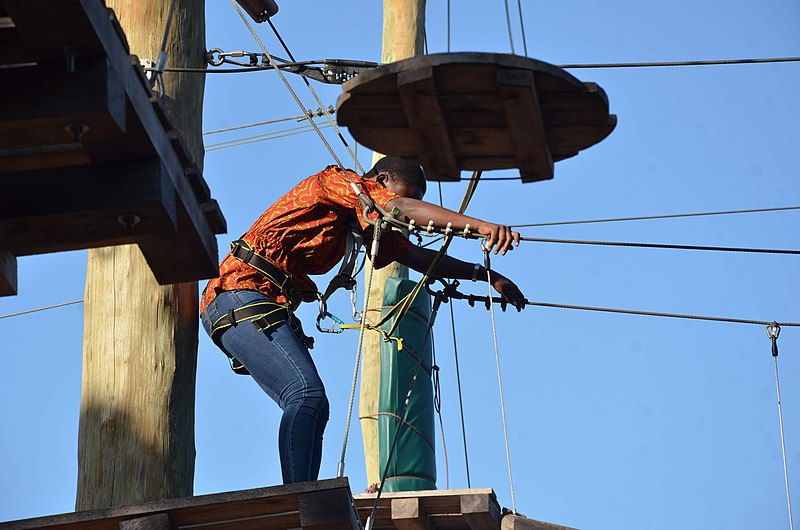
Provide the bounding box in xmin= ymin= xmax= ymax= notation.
xmin=297 ymin=489 xmax=360 ymax=530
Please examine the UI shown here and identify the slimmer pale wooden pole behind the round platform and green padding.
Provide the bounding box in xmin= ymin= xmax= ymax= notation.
xmin=358 ymin=0 xmax=426 ymax=484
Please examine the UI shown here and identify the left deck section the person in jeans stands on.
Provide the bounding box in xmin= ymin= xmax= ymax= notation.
xmin=0 ymin=478 xmax=359 ymax=530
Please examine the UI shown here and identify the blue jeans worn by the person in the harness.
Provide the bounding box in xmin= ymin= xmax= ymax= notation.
xmin=201 ymin=291 xmax=329 ymax=484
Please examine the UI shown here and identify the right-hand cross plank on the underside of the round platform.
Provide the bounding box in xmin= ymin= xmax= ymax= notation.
xmin=497 ymin=69 xmax=553 ymax=182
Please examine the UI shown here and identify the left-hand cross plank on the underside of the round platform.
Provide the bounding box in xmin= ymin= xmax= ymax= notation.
xmin=397 ymin=68 xmax=461 ymax=181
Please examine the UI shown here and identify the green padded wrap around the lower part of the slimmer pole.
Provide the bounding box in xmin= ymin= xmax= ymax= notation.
xmin=378 ymin=278 xmax=436 ymax=491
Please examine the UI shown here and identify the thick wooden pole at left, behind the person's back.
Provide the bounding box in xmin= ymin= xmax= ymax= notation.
xmin=76 ymin=0 xmax=205 ymax=510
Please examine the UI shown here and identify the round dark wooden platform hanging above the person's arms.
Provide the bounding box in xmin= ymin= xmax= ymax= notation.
xmin=336 ymin=52 xmax=617 ymax=182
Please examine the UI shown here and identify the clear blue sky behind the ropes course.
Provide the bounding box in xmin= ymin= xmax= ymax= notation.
xmin=0 ymin=0 xmax=800 ymax=529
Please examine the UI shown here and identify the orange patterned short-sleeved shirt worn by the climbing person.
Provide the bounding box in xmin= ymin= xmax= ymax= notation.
xmin=200 ymin=166 xmax=411 ymax=313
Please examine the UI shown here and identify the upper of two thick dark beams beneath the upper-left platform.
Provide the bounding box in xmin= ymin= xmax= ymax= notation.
xmin=0 ymin=57 xmax=125 ymax=154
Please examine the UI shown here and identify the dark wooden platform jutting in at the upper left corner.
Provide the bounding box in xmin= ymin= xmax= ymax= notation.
xmin=0 ymin=0 xmax=226 ymax=296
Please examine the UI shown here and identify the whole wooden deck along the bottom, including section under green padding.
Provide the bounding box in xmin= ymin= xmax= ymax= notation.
xmin=0 ymin=478 xmax=574 ymax=530
